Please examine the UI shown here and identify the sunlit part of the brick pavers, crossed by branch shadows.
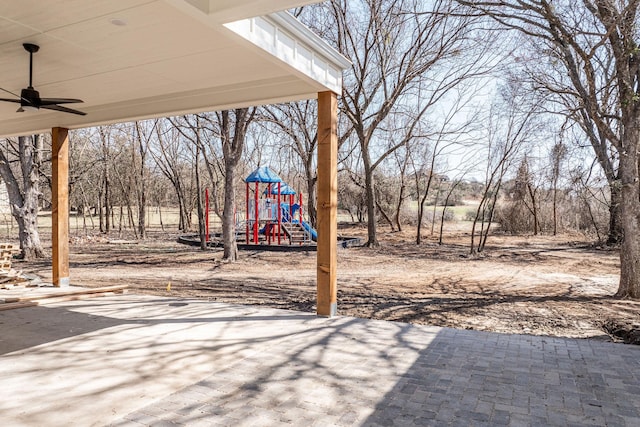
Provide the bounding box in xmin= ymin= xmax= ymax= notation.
xmin=113 ymin=310 xmax=437 ymax=426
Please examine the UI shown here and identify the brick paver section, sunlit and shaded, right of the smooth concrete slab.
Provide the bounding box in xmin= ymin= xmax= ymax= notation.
xmin=115 ymin=302 xmax=640 ymax=426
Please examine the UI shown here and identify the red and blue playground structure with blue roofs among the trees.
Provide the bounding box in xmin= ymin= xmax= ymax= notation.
xmin=242 ymin=166 xmax=318 ymax=245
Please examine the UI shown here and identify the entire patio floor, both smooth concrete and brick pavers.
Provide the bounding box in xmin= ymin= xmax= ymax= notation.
xmin=0 ymin=294 xmax=640 ymax=426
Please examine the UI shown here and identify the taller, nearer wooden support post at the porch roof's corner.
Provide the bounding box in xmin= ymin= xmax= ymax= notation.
xmin=317 ymin=92 xmax=338 ymax=316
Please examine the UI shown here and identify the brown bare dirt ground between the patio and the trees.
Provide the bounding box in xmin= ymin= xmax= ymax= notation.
xmin=15 ymin=227 xmax=640 ymax=342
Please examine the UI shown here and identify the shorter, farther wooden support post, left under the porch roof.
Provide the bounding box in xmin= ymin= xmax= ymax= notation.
xmin=51 ymin=128 xmax=69 ymax=287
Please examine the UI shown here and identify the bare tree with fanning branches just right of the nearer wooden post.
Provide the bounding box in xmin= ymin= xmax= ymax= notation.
xmin=301 ymin=0 xmax=490 ymax=246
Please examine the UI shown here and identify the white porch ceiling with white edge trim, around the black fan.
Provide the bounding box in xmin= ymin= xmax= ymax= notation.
xmin=0 ymin=0 xmax=347 ymax=136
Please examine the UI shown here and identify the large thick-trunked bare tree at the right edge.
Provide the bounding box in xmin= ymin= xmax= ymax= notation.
xmin=458 ymin=0 xmax=640 ymax=298
